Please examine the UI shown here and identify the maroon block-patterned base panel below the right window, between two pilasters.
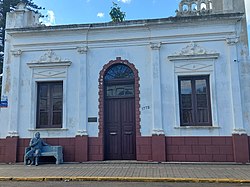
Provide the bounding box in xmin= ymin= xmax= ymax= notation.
xmin=166 ymin=137 xmax=234 ymax=162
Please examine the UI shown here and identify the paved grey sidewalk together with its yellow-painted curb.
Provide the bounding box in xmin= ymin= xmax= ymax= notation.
xmin=0 ymin=161 xmax=250 ymax=183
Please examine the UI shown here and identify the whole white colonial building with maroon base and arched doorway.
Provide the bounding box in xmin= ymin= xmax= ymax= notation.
xmin=0 ymin=0 xmax=250 ymax=163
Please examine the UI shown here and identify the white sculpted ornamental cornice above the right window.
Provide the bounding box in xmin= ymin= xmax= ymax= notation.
xmin=168 ymin=42 xmax=220 ymax=61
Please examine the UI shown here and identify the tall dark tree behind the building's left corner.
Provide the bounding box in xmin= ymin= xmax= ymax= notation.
xmin=0 ymin=0 xmax=43 ymax=98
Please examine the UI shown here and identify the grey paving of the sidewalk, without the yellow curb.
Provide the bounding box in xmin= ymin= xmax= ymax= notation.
xmin=0 ymin=162 xmax=250 ymax=180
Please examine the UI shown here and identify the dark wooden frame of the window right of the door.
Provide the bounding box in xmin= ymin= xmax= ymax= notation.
xmin=178 ymin=75 xmax=212 ymax=127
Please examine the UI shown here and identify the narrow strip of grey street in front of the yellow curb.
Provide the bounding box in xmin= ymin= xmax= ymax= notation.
xmin=0 ymin=182 xmax=250 ymax=187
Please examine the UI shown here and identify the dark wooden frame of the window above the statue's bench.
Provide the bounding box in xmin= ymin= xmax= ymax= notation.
xmin=36 ymin=81 xmax=64 ymax=129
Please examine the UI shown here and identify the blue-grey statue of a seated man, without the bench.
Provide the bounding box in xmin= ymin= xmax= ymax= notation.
xmin=25 ymin=132 xmax=48 ymax=166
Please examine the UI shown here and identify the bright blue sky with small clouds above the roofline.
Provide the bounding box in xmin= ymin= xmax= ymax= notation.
xmin=33 ymin=0 xmax=250 ymax=41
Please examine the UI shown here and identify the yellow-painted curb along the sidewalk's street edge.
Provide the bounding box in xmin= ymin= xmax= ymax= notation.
xmin=0 ymin=177 xmax=250 ymax=183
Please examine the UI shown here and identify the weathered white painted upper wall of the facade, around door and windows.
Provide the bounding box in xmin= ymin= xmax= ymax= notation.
xmin=0 ymin=5 xmax=250 ymax=138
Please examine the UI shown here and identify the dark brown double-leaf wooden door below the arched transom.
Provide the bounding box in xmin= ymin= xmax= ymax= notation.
xmin=105 ymin=97 xmax=136 ymax=160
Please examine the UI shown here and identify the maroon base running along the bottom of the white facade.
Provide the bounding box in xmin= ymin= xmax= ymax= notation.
xmin=0 ymin=135 xmax=250 ymax=163
